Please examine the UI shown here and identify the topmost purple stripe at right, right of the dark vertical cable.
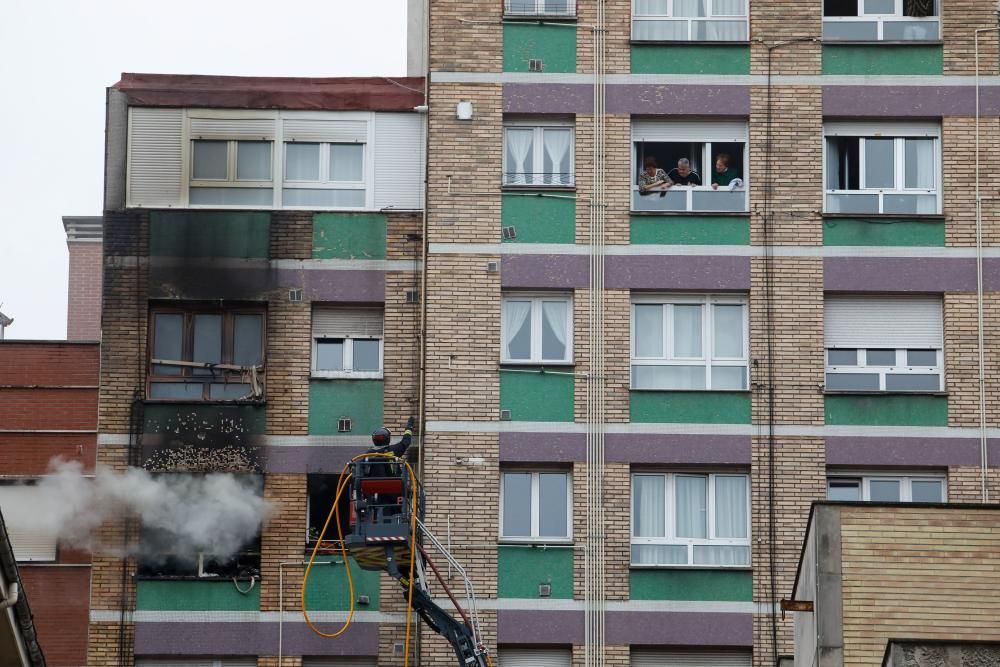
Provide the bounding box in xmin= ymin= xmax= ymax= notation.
xmin=823 ymin=86 xmax=1000 ymax=118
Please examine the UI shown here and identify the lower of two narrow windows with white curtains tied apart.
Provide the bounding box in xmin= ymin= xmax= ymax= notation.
xmin=500 ymin=293 xmax=573 ymax=364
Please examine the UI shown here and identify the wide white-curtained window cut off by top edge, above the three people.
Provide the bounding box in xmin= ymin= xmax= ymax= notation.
xmin=632 ymin=0 xmax=749 ymax=42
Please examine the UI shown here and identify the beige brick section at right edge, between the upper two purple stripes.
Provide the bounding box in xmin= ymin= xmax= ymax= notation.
xmin=941 ymin=116 xmax=1000 ymax=247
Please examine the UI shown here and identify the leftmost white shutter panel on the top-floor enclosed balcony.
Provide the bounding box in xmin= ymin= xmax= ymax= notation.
xmin=126 ymin=107 xmax=184 ymax=207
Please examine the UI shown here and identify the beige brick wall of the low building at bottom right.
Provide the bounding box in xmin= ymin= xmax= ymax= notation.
xmin=840 ymin=507 xmax=1000 ymax=665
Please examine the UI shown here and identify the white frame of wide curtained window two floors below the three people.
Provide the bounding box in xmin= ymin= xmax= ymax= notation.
xmin=629 ymin=470 xmax=753 ymax=570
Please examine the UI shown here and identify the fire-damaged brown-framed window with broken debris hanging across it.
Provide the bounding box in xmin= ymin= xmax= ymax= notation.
xmin=148 ymin=307 xmax=265 ymax=401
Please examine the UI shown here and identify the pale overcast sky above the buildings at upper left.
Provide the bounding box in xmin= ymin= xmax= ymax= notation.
xmin=0 ymin=0 xmax=406 ymax=339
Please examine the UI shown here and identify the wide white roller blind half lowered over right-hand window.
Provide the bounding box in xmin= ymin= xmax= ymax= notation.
xmin=824 ymin=296 xmax=944 ymax=349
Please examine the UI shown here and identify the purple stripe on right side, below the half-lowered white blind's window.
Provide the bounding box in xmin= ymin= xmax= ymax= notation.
xmin=826 ymin=436 xmax=1000 ymax=468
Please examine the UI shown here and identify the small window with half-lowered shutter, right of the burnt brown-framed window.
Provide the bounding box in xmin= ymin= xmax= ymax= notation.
xmin=313 ymin=307 xmax=383 ymax=378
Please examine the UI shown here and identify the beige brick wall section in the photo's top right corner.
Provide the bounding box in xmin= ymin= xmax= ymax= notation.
xmin=941 ymin=0 xmax=997 ymax=74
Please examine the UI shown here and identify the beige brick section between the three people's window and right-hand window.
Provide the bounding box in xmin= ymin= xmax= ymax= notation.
xmin=748 ymin=86 xmax=823 ymax=245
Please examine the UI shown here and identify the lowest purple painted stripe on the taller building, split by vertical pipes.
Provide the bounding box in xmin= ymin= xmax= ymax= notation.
xmin=497 ymin=609 xmax=753 ymax=647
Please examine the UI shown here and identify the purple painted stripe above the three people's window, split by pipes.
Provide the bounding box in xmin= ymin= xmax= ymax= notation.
xmin=503 ymin=83 xmax=750 ymax=116
